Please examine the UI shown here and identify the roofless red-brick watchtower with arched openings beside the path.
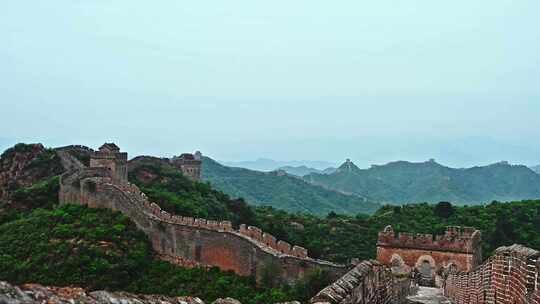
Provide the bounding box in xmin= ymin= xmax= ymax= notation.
xmin=377 ymin=226 xmax=482 ymax=285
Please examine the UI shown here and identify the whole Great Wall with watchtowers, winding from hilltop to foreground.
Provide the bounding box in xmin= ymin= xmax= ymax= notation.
xmin=57 ymin=144 xmax=540 ymax=304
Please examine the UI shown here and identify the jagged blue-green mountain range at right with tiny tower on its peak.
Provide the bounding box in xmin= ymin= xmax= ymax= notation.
xmin=304 ymin=160 xmax=540 ymax=205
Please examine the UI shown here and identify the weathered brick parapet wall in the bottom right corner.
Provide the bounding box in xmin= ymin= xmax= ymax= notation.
xmin=444 ymin=245 xmax=540 ymax=304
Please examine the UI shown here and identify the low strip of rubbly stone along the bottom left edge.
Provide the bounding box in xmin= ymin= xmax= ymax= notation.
xmin=0 ymin=282 xmax=206 ymax=304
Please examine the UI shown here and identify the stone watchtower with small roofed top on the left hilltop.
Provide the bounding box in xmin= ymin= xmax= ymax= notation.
xmin=90 ymin=143 xmax=128 ymax=182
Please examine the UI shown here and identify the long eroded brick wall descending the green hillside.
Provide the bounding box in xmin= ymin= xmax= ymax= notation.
xmin=59 ymin=168 xmax=348 ymax=283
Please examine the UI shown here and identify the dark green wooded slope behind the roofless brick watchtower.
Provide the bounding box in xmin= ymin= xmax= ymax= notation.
xmin=252 ymin=200 xmax=540 ymax=262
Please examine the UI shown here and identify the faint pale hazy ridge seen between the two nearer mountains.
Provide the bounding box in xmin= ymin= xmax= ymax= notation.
xmin=219 ymin=158 xmax=338 ymax=175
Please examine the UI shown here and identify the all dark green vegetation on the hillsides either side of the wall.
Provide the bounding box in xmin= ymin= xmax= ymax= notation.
xmin=0 ymin=143 xmax=540 ymax=303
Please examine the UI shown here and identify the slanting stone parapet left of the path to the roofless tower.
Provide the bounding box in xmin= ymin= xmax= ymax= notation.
xmin=310 ymin=261 xmax=413 ymax=304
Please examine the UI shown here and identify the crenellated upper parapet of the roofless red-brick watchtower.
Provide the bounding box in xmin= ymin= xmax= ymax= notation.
xmin=377 ymin=226 xmax=481 ymax=254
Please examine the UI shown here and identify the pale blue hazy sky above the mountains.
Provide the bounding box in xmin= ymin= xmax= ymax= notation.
xmin=0 ymin=0 xmax=540 ymax=166
